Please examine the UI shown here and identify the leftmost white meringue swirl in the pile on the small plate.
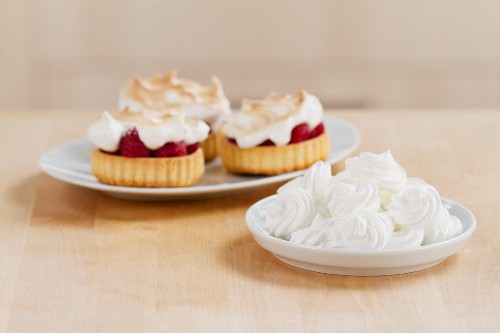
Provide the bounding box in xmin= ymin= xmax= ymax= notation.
xmin=262 ymin=188 xmax=315 ymax=240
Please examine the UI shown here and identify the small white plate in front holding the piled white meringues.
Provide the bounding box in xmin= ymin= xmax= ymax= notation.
xmin=245 ymin=196 xmax=476 ymax=276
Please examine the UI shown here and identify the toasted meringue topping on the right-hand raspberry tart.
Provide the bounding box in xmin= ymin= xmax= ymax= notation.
xmin=226 ymin=91 xmax=323 ymax=148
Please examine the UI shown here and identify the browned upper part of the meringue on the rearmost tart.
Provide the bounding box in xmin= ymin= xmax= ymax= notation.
xmin=120 ymin=70 xmax=229 ymax=113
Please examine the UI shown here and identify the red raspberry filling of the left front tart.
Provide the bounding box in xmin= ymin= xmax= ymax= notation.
xmin=105 ymin=128 xmax=200 ymax=157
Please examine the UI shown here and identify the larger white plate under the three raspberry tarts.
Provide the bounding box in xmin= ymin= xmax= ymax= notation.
xmin=39 ymin=116 xmax=360 ymax=200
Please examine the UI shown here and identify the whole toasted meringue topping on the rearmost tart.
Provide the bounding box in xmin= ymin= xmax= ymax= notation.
xmin=119 ymin=70 xmax=231 ymax=130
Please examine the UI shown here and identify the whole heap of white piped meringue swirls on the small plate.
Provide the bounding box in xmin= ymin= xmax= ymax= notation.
xmin=258 ymin=151 xmax=462 ymax=250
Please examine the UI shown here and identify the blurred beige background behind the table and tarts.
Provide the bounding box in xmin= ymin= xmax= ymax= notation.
xmin=0 ymin=0 xmax=500 ymax=110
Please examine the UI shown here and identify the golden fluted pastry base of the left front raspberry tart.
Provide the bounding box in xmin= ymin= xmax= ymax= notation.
xmin=91 ymin=149 xmax=205 ymax=187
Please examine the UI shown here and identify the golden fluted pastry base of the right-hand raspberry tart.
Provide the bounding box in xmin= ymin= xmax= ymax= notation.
xmin=219 ymin=133 xmax=330 ymax=175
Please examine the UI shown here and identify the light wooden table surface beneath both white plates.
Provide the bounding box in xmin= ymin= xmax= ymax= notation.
xmin=0 ymin=110 xmax=500 ymax=332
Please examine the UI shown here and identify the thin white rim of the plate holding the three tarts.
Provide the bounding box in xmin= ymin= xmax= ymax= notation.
xmin=38 ymin=115 xmax=361 ymax=198
